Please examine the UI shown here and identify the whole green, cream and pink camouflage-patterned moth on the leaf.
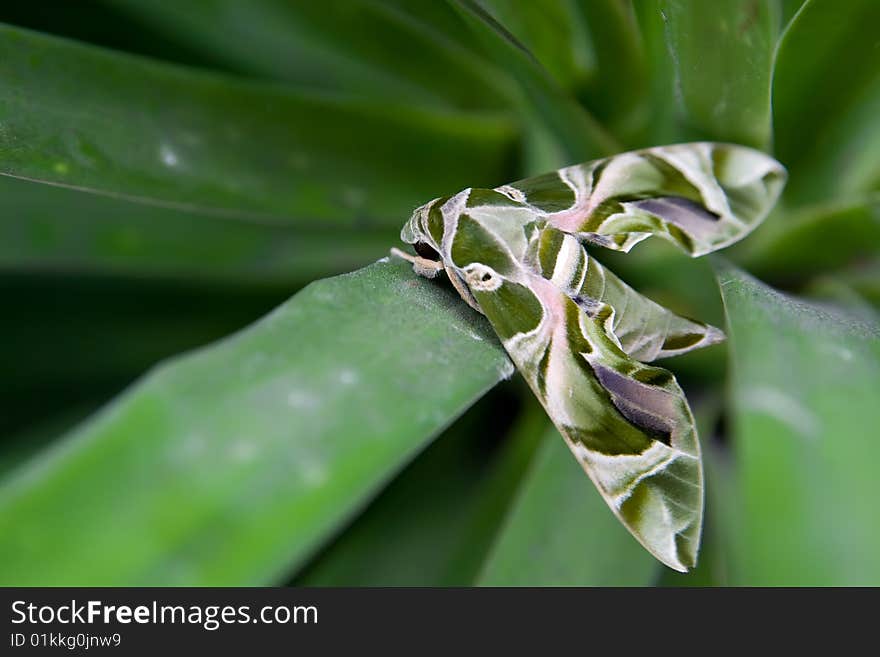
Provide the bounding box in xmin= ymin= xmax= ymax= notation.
xmin=393 ymin=142 xmax=787 ymax=572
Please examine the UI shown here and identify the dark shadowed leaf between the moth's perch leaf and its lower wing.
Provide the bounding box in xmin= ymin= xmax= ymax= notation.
xmin=294 ymin=391 xmax=547 ymax=586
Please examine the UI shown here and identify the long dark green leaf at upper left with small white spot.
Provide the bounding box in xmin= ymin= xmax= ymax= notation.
xmin=0 ymin=27 xmax=514 ymax=223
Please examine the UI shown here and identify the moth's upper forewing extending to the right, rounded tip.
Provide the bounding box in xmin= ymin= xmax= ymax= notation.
xmin=507 ymin=142 xmax=787 ymax=256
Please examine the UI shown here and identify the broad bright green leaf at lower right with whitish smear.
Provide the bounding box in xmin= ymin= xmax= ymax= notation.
xmin=718 ymin=265 xmax=880 ymax=586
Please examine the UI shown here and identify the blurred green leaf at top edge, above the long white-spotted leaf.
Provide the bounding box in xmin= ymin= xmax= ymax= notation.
xmin=109 ymin=0 xmax=506 ymax=108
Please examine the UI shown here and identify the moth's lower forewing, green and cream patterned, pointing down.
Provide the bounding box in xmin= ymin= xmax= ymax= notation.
xmin=474 ymin=274 xmax=703 ymax=571
